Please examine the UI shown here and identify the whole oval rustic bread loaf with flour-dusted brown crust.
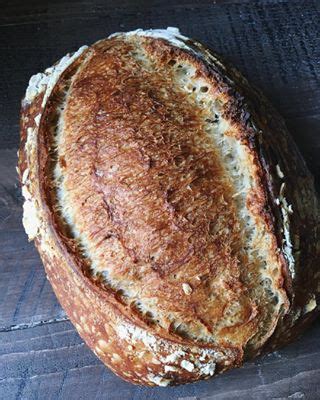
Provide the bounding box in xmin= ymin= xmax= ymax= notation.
xmin=19 ymin=28 xmax=320 ymax=386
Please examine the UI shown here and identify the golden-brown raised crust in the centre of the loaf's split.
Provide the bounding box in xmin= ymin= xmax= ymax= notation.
xmin=57 ymin=38 xmax=264 ymax=344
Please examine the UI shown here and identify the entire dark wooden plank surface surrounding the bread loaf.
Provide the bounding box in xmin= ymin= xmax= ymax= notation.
xmin=0 ymin=0 xmax=320 ymax=400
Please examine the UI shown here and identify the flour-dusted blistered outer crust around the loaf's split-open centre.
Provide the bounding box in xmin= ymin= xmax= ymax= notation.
xmin=19 ymin=27 xmax=319 ymax=386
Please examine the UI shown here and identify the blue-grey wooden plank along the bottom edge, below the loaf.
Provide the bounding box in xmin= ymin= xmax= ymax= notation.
xmin=0 ymin=322 xmax=320 ymax=400
